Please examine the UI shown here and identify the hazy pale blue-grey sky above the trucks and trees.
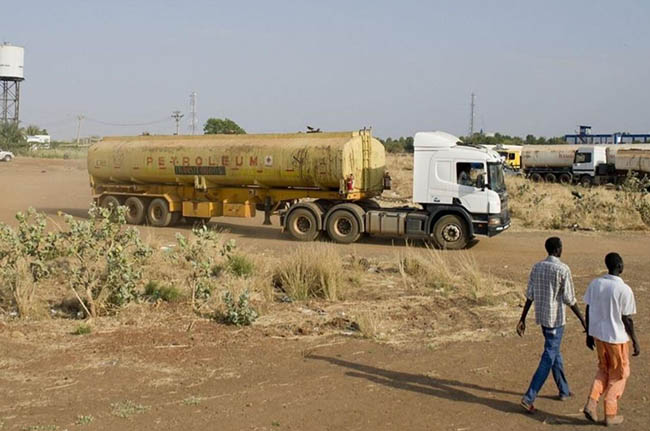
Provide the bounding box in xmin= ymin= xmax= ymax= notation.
xmin=0 ymin=0 xmax=650 ymax=139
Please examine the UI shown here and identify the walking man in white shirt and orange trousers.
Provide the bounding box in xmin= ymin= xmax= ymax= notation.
xmin=584 ymin=253 xmax=641 ymax=425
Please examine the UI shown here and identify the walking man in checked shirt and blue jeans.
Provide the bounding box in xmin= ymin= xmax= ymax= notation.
xmin=517 ymin=237 xmax=585 ymax=413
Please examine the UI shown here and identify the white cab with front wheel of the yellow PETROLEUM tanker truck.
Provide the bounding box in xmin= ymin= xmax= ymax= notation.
xmin=413 ymin=131 xmax=510 ymax=248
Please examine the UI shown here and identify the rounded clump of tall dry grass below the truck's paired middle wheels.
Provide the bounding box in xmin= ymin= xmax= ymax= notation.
xmin=273 ymin=244 xmax=345 ymax=301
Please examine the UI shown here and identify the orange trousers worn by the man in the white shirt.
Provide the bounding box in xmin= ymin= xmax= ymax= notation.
xmin=589 ymin=339 xmax=630 ymax=416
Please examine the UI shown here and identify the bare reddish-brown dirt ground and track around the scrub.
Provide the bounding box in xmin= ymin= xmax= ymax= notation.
xmin=0 ymin=158 xmax=650 ymax=431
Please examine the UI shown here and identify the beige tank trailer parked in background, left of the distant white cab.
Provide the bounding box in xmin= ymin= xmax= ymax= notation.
xmin=521 ymin=145 xmax=578 ymax=184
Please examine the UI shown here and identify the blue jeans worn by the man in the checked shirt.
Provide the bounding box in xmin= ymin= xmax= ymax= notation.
xmin=524 ymin=326 xmax=570 ymax=404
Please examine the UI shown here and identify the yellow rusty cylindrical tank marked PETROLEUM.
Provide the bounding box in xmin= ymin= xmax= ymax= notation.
xmin=88 ymin=130 xmax=386 ymax=194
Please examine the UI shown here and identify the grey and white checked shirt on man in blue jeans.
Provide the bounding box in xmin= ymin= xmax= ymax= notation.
xmin=526 ymin=256 xmax=576 ymax=328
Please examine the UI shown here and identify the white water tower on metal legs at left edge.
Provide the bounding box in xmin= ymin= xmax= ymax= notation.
xmin=0 ymin=43 xmax=25 ymax=124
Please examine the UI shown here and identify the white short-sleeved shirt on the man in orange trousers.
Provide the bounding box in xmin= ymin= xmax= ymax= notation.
xmin=584 ymin=274 xmax=636 ymax=344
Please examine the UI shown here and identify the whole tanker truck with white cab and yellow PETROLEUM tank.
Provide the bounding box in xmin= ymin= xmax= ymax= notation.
xmin=88 ymin=130 xmax=510 ymax=249
